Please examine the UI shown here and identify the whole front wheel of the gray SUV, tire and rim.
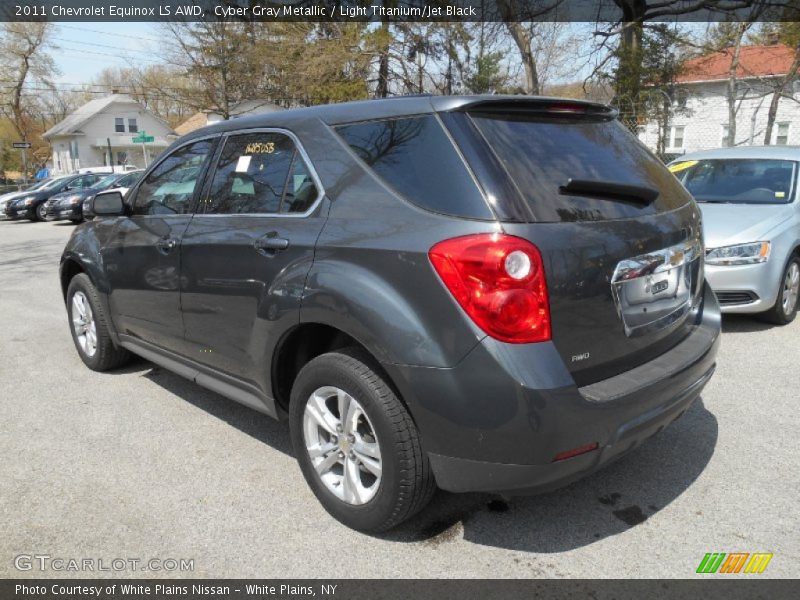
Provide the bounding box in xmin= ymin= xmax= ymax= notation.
xmin=67 ymin=273 xmax=130 ymax=371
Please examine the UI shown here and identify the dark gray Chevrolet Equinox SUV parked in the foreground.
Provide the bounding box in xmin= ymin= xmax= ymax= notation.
xmin=60 ymin=96 xmax=720 ymax=531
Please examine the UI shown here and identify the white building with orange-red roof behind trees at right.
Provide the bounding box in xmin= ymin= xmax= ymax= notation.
xmin=639 ymin=44 xmax=800 ymax=154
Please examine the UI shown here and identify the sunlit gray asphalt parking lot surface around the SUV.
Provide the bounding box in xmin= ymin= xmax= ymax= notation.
xmin=0 ymin=221 xmax=800 ymax=578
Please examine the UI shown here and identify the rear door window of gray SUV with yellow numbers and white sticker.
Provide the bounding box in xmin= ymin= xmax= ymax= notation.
xmin=203 ymin=133 xmax=318 ymax=215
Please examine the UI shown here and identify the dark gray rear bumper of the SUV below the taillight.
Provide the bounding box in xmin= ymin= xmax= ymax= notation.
xmin=387 ymin=286 xmax=720 ymax=494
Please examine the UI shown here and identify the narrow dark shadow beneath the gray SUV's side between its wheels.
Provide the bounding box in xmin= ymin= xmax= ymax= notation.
xmin=110 ymin=356 xmax=294 ymax=456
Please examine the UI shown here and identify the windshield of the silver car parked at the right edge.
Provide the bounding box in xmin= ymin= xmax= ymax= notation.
xmin=675 ymin=158 xmax=797 ymax=204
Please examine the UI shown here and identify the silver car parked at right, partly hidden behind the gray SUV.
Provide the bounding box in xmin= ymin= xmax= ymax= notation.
xmin=670 ymin=146 xmax=800 ymax=325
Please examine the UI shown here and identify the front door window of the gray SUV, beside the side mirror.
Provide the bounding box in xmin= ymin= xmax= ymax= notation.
xmin=133 ymin=140 xmax=213 ymax=215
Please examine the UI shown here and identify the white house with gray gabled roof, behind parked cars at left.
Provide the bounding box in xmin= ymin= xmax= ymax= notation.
xmin=43 ymin=93 xmax=176 ymax=175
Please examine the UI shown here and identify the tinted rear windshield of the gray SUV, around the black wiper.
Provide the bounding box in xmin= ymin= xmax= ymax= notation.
xmin=470 ymin=113 xmax=691 ymax=221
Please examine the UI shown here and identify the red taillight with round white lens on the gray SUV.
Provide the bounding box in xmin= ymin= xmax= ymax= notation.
xmin=428 ymin=233 xmax=550 ymax=344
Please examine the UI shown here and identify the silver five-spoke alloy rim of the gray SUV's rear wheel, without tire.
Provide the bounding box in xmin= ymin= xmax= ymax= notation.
xmin=303 ymin=386 xmax=383 ymax=505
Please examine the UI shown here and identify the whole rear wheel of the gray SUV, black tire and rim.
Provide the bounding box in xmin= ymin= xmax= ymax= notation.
xmin=289 ymin=348 xmax=436 ymax=532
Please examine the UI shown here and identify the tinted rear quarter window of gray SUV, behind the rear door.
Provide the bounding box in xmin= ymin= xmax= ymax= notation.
xmin=336 ymin=115 xmax=492 ymax=219
